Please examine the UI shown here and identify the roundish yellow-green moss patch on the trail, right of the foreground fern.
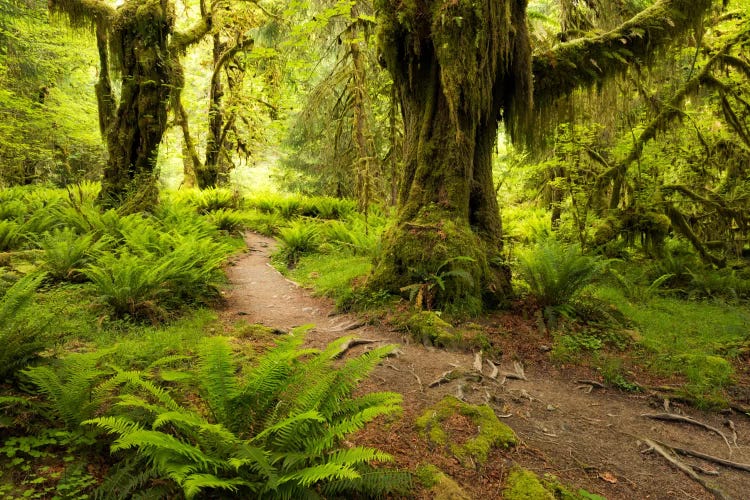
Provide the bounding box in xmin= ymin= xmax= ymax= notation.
xmin=416 ymin=396 xmax=518 ymax=465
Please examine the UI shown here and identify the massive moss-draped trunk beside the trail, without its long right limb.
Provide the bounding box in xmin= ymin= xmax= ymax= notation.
xmin=369 ymin=0 xmax=531 ymax=312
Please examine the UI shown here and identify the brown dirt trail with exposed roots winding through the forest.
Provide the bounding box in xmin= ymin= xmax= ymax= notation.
xmin=221 ymin=233 xmax=750 ymax=499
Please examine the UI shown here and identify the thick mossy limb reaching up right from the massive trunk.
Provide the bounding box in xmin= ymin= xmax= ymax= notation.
xmin=532 ymin=0 xmax=711 ymax=105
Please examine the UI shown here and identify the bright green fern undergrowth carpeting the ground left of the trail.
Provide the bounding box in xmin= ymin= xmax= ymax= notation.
xmin=0 ymin=184 xmax=410 ymax=498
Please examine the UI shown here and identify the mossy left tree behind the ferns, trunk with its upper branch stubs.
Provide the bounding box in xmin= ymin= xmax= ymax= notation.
xmin=49 ymin=0 xmax=210 ymax=212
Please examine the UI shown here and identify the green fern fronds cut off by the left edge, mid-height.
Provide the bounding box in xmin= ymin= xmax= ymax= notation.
xmin=0 ymin=274 xmax=49 ymax=380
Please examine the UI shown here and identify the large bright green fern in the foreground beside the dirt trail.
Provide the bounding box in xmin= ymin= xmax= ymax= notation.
xmin=85 ymin=334 xmax=408 ymax=498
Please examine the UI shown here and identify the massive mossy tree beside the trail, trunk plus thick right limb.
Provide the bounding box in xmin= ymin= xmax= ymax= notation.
xmin=376 ymin=0 xmax=711 ymax=311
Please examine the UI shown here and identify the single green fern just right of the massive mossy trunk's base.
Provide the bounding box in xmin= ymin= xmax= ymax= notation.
xmin=519 ymin=238 xmax=602 ymax=307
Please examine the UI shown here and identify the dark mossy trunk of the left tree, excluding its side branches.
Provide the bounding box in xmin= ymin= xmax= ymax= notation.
xmin=99 ymin=0 xmax=174 ymax=212
